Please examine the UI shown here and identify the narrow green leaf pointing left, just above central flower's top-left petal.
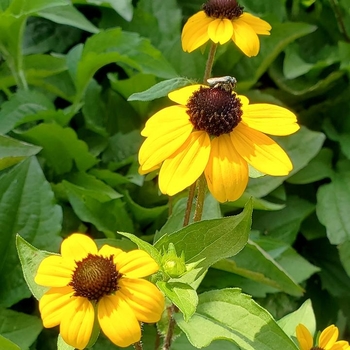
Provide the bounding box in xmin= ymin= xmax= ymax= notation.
xmin=128 ymin=78 xmax=192 ymax=101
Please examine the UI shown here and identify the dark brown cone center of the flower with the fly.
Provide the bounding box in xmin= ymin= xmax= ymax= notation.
xmin=186 ymin=86 xmax=243 ymax=136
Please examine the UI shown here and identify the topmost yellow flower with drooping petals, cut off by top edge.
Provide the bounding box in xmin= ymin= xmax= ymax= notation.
xmin=181 ymin=0 xmax=271 ymax=57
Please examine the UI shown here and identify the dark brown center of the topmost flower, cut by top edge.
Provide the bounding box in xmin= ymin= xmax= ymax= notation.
xmin=203 ymin=0 xmax=243 ymax=20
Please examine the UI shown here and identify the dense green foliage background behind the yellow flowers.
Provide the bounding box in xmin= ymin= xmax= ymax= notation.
xmin=0 ymin=0 xmax=350 ymax=350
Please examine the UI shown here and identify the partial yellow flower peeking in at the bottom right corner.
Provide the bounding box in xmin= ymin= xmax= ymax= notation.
xmin=296 ymin=324 xmax=350 ymax=350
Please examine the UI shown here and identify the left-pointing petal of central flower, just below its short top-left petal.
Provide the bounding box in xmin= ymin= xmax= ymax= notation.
xmin=141 ymin=104 xmax=190 ymax=137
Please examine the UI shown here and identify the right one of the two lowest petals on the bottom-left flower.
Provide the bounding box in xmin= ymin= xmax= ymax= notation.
xmin=97 ymin=291 xmax=141 ymax=347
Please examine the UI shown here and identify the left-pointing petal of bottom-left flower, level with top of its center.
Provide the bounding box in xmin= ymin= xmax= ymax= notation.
xmin=34 ymin=255 xmax=75 ymax=287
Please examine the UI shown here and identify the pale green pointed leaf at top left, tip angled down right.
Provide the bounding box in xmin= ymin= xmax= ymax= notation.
xmin=38 ymin=4 xmax=99 ymax=33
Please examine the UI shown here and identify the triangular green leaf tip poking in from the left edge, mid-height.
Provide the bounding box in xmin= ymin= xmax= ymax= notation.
xmin=0 ymin=135 xmax=41 ymax=170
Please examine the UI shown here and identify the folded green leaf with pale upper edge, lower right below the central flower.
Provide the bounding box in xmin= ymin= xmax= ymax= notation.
xmin=214 ymin=241 xmax=303 ymax=296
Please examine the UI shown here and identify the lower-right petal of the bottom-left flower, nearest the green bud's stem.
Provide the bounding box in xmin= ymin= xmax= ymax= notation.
xmin=119 ymin=278 xmax=164 ymax=323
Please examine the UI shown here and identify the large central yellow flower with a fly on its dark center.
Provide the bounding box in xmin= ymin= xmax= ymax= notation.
xmin=139 ymin=84 xmax=299 ymax=202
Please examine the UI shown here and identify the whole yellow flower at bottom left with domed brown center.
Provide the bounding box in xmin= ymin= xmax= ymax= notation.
xmin=35 ymin=233 xmax=164 ymax=349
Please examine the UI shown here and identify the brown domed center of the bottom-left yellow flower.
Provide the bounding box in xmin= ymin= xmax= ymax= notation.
xmin=69 ymin=254 xmax=122 ymax=302
